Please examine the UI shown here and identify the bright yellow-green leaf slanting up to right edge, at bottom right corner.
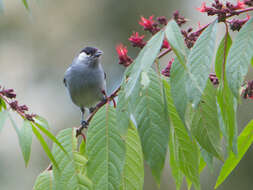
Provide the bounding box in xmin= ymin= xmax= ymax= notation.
xmin=215 ymin=120 xmax=253 ymax=189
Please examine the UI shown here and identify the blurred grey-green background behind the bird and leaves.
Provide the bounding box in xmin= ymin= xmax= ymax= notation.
xmin=0 ymin=0 xmax=253 ymax=190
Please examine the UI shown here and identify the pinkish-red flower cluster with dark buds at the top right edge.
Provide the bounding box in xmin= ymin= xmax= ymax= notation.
xmin=197 ymin=0 xmax=245 ymax=22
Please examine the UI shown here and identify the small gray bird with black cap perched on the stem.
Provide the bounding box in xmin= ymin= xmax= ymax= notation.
xmin=63 ymin=47 xmax=106 ymax=127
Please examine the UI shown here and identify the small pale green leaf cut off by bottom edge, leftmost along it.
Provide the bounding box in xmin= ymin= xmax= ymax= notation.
xmin=33 ymin=171 xmax=54 ymax=190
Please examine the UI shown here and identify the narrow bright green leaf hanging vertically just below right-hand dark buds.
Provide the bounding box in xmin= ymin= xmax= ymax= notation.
xmin=217 ymin=82 xmax=237 ymax=153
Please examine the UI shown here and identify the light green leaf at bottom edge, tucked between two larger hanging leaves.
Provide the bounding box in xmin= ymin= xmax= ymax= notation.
xmin=120 ymin=122 xmax=144 ymax=190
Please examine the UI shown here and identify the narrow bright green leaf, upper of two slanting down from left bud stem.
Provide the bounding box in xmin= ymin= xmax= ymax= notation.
xmin=32 ymin=121 xmax=68 ymax=157
